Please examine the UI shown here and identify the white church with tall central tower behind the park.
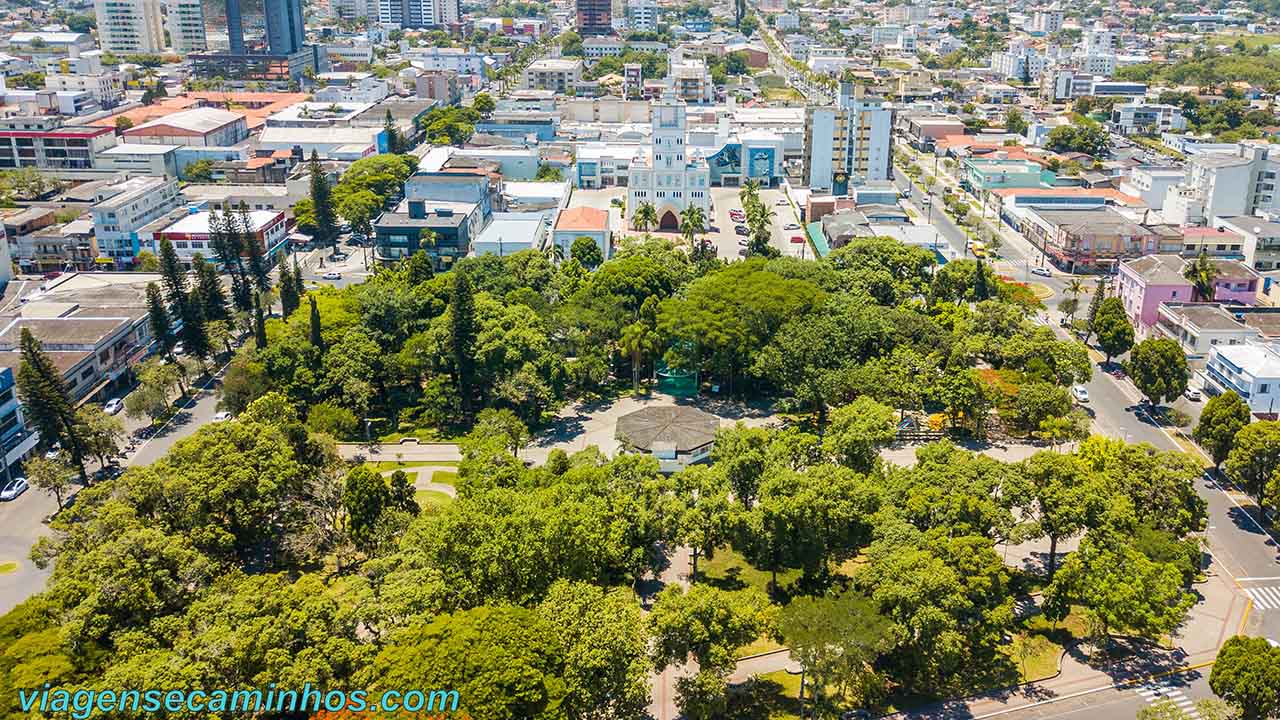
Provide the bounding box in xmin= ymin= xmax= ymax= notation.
xmin=627 ymin=91 xmax=712 ymax=231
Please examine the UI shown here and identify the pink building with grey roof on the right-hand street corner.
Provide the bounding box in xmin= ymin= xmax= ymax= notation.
xmin=1115 ymin=255 xmax=1261 ymax=338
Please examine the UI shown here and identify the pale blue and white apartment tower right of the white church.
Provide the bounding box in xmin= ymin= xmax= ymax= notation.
xmin=801 ymin=82 xmax=893 ymax=195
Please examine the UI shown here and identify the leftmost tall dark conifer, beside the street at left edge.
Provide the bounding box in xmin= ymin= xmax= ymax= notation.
xmin=17 ymin=328 xmax=88 ymax=484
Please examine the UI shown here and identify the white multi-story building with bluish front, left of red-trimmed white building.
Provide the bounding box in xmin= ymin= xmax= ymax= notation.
xmin=91 ymin=177 xmax=182 ymax=268
